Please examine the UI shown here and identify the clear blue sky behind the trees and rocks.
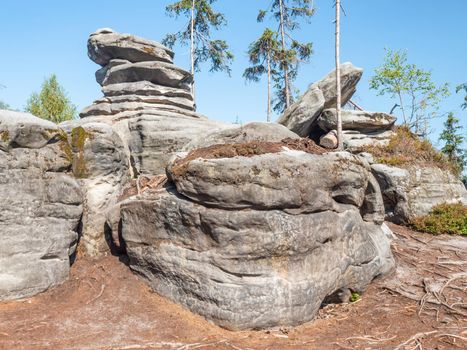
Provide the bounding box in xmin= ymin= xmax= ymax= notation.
xmin=0 ymin=0 xmax=467 ymax=146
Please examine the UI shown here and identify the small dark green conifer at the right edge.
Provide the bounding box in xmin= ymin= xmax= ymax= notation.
xmin=439 ymin=113 xmax=467 ymax=173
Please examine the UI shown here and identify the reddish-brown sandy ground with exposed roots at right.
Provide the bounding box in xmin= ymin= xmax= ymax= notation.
xmin=0 ymin=225 xmax=467 ymax=350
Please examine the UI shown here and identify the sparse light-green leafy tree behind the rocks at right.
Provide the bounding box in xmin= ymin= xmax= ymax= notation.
xmin=370 ymin=49 xmax=449 ymax=137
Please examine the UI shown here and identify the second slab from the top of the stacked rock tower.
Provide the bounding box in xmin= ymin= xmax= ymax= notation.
xmin=101 ymin=62 xmax=193 ymax=91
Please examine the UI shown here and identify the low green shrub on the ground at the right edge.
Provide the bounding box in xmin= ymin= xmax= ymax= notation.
xmin=411 ymin=203 xmax=467 ymax=235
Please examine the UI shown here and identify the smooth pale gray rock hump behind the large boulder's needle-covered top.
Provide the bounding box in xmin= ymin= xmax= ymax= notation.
xmin=183 ymin=122 xmax=299 ymax=151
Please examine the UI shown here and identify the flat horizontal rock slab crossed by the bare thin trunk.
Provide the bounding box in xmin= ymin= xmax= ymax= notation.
xmin=318 ymin=108 xmax=396 ymax=132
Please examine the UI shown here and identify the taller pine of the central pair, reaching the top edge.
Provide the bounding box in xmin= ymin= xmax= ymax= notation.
xmin=257 ymin=0 xmax=314 ymax=112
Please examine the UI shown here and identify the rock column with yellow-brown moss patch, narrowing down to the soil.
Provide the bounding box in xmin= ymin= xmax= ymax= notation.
xmin=61 ymin=120 xmax=131 ymax=257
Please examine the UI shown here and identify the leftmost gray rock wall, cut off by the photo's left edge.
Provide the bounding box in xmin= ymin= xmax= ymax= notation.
xmin=0 ymin=110 xmax=83 ymax=300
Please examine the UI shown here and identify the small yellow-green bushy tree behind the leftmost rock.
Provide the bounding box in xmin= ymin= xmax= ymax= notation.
xmin=25 ymin=74 xmax=76 ymax=123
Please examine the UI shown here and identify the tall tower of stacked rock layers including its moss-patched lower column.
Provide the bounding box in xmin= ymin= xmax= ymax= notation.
xmin=71 ymin=29 xmax=228 ymax=256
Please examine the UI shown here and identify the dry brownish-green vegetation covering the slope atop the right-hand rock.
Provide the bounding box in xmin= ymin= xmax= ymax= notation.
xmin=361 ymin=126 xmax=459 ymax=175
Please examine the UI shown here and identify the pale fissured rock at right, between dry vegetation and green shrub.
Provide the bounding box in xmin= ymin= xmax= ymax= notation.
xmin=371 ymin=164 xmax=467 ymax=224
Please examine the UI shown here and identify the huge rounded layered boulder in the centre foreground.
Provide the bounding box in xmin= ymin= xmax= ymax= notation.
xmin=121 ymin=144 xmax=394 ymax=329
